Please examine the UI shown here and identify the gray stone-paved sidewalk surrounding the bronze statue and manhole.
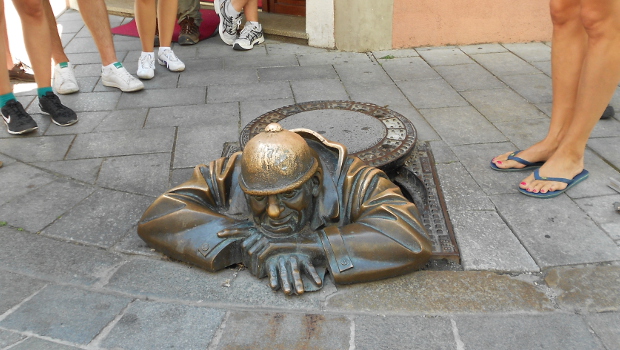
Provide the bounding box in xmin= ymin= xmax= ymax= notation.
xmin=0 ymin=10 xmax=620 ymax=350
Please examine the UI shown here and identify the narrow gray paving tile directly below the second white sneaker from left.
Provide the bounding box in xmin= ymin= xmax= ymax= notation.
xmin=117 ymin=87 xmax=206 ymax=109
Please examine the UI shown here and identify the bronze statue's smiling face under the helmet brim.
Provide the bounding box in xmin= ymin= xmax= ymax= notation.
xmin=246 ymin=176 xmax=319 ymax=237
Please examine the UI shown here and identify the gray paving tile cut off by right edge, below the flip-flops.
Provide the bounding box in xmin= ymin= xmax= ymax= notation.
xmin=575 ymin=194 xmax=620 ymax=241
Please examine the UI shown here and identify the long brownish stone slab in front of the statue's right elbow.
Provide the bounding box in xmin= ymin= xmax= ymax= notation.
xmin=326 ymin=271 xmax=553 ymax=314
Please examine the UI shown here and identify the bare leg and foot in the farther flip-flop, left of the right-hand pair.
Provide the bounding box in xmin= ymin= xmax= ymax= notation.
xmin=493 ymin=0 xmax=587 ymax=168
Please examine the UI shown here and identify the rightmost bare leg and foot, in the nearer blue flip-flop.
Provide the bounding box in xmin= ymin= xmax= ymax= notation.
xmin=520 ymin=0 xmax=620 ymax=193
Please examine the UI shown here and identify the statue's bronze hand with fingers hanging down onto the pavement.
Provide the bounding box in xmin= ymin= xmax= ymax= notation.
xmin=267 ymin=253 xmax=323 ymax=295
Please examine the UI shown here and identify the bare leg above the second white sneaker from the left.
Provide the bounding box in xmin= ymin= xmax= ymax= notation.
xmin=78 ymin=0 xmax=118 ymax=66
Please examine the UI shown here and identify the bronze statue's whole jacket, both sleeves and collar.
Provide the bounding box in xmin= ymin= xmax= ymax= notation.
xmin=138 ymin=135 xmax=431 ymax=284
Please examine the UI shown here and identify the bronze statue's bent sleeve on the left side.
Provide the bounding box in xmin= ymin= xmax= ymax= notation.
xmin=138 ymin=153 xmax=247 ymax=271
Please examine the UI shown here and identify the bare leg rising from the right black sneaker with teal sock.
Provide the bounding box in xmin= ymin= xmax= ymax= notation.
xmin=13 ymin=0 xmax=52 ymax=88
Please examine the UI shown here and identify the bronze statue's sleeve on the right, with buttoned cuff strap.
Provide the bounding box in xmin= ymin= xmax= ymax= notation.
xmin=320 ymin=159 xmax=432 ymax=284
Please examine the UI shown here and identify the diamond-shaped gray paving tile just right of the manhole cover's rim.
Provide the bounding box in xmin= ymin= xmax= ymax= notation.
xmin=420 ymin=107 xmax=506 ymax=145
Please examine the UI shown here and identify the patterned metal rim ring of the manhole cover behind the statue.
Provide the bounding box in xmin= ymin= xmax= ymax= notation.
xmin=239 ymin=101 xmax=417 ymax=169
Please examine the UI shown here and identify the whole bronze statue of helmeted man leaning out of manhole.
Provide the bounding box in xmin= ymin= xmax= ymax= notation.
xmin=138 ymin=124 xmax=431 ymax=295
